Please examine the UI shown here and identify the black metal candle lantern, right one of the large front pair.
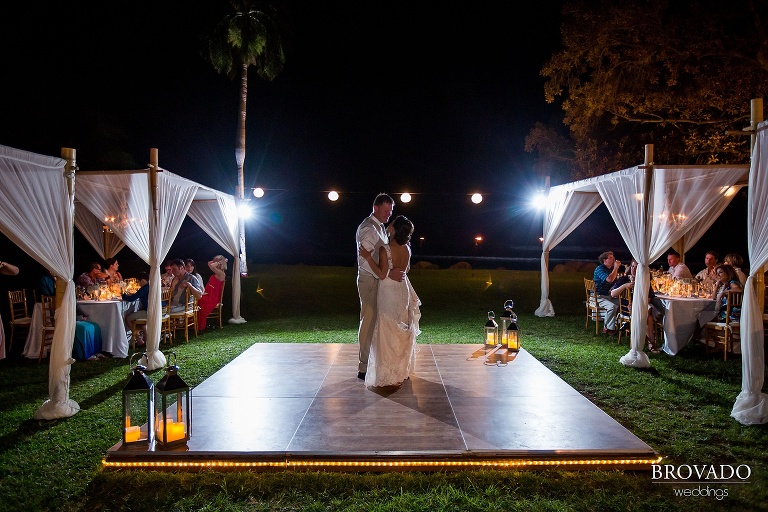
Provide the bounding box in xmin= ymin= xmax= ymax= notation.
xmin=155 ymin=352 xmax=192 ymax=449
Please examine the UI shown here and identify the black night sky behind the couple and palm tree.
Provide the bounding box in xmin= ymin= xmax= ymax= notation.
xmin=0 ymin=0 xmax=744 ymax=272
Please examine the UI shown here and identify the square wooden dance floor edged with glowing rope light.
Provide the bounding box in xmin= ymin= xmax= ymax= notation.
xmin=104 ymin=344 xmax=660 ymax=471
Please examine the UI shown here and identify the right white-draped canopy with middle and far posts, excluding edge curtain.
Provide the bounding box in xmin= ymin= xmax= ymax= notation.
xmin=535 ymin=145 xmax=749 ymax=368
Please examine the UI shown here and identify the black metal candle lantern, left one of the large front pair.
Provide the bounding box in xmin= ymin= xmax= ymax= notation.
xmin=122 ymin=353 xmax=155 ymax=445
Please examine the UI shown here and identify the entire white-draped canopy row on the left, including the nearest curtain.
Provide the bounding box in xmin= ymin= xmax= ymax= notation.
xmin=0 ymin=145 xmax=245 ymax=419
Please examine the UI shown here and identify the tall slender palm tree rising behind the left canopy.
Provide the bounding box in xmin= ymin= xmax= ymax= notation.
xmin=203 ymin=0 xmax=286 ymax=275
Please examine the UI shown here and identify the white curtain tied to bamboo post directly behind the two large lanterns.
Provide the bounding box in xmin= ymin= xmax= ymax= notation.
xmin=77 ymin=170 xmax=199 ymax=370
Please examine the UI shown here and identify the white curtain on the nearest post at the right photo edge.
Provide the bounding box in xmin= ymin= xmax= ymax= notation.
xmin=731 ymin=122 xmax=768 ymax=425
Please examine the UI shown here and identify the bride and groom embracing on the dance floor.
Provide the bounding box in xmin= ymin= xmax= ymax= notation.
xmin=356 ymin=194 xmax=421 ymax=387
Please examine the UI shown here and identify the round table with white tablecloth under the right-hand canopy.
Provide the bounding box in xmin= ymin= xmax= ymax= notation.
xmin=657 ymin=295 xmax=717 ymax=356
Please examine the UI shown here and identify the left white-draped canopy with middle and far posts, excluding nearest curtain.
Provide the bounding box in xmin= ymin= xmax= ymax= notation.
xmin=75 ymin=149 xmax=245 ymax=369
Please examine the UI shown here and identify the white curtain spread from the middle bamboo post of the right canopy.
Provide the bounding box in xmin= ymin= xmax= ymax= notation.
xmin=595 ymin=166 xmax=747 ymax=368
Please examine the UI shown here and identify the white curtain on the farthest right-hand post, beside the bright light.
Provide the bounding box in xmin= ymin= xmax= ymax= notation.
xmin=535 ymin=185 xmax=602 ymax=317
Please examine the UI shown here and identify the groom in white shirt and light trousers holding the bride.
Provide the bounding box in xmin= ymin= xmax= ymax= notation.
xmin=355 ymin=194 xmax=403 ymax=380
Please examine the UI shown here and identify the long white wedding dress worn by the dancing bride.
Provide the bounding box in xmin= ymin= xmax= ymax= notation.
xmin=365 ymin=245 xmax=421 ymax=387
